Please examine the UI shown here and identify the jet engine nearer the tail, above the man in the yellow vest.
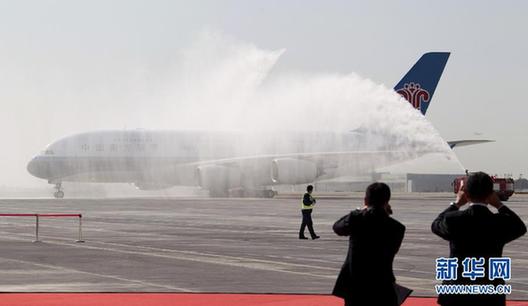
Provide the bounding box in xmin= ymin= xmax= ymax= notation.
xmin=271 ymin=158 xmax=317 ymax=184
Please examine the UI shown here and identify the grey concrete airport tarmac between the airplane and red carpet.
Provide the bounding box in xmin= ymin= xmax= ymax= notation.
xmin=0 ymin=194 xmax=528 ymax=300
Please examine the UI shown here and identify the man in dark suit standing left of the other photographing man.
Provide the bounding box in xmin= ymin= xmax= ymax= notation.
xmin=332 ymin=183 xmax=405 ymax=306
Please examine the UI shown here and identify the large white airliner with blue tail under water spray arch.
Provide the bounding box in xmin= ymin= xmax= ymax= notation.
xmin=27 ymin=52 xmax=485 ymax=198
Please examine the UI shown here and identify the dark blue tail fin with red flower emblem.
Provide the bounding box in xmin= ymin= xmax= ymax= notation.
xmin=394 ymin=52 xmax=449 ymax=115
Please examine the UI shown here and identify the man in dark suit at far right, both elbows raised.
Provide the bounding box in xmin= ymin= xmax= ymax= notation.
xmin=431 ymin=172 xmax=526 ymax=306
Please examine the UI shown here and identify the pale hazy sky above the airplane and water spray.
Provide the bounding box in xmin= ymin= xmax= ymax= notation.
xmin=0 ymin=0 xmax=528 ymax=186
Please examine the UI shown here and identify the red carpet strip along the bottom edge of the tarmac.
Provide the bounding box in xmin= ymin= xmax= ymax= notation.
xmin=0 ymin=293 xmax=528 ymax=306
